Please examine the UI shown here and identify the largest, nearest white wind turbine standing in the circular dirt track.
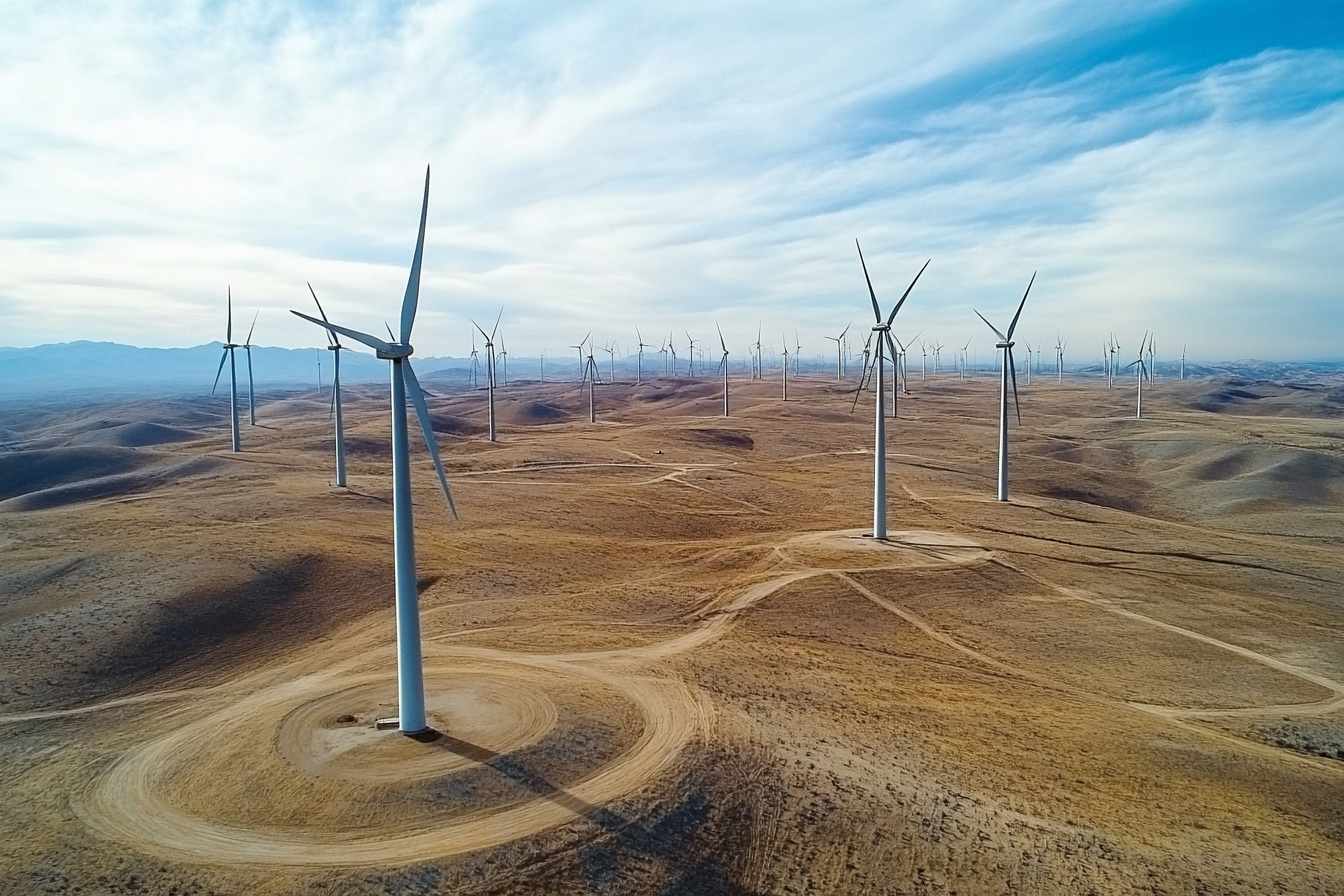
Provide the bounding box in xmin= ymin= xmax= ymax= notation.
xmin=293 ymin=167 xmax=457 ymax=735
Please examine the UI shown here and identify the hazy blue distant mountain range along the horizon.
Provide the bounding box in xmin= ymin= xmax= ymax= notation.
xmin=0 ymin=341 xmax=1344 ymax=398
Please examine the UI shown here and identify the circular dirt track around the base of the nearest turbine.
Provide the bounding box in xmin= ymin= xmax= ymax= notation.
xmin=77 ymin=657 xmax=702 ymax=866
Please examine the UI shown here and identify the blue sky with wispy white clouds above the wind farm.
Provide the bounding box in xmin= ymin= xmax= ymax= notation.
xmin=0 ymin=0 xmax=1344 ymax=363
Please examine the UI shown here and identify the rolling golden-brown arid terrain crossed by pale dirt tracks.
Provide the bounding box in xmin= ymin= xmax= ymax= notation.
xmin=0 ymin=373 xmax=1344 ymax=896
